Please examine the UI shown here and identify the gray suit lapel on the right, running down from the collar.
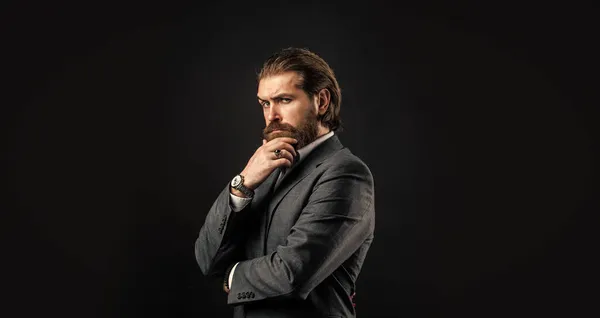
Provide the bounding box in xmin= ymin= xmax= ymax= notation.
xmin=265 ymin=135 xmax=344 ymax=240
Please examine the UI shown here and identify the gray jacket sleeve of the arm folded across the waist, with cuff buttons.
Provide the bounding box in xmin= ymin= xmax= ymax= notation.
xmin=227 ymin=161 xmax=375 ymax=305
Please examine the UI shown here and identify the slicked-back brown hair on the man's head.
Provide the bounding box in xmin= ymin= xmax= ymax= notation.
xmin=257 ymin=47 xmax=342 ymax=130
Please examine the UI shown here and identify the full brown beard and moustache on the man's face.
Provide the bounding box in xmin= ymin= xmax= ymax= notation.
xmin=262 ymin=111 xmax=319 ymax=149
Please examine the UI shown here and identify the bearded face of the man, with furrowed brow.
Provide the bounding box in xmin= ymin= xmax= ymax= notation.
xmin=257 ymin=72 xmax=319 ymax=149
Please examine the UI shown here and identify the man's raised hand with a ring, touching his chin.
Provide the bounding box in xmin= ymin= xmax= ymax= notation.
xmin=241 ymin=137 xmax=298 ymax=190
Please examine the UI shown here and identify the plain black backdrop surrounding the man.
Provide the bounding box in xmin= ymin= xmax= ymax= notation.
xmin=3 ymin=1 xmax=598 ymax=317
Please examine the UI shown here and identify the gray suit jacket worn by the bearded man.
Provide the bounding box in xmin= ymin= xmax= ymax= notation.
xmin=195 ymin=135 xmax=375 ymax=318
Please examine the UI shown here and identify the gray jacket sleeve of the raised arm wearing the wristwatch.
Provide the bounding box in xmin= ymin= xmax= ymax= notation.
xmin=195 ymin=184 xmax=255 ymax=276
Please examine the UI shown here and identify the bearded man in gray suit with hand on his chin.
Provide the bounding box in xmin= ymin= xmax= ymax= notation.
xmin=195 ymin=48 xmax=375 ymax=318
